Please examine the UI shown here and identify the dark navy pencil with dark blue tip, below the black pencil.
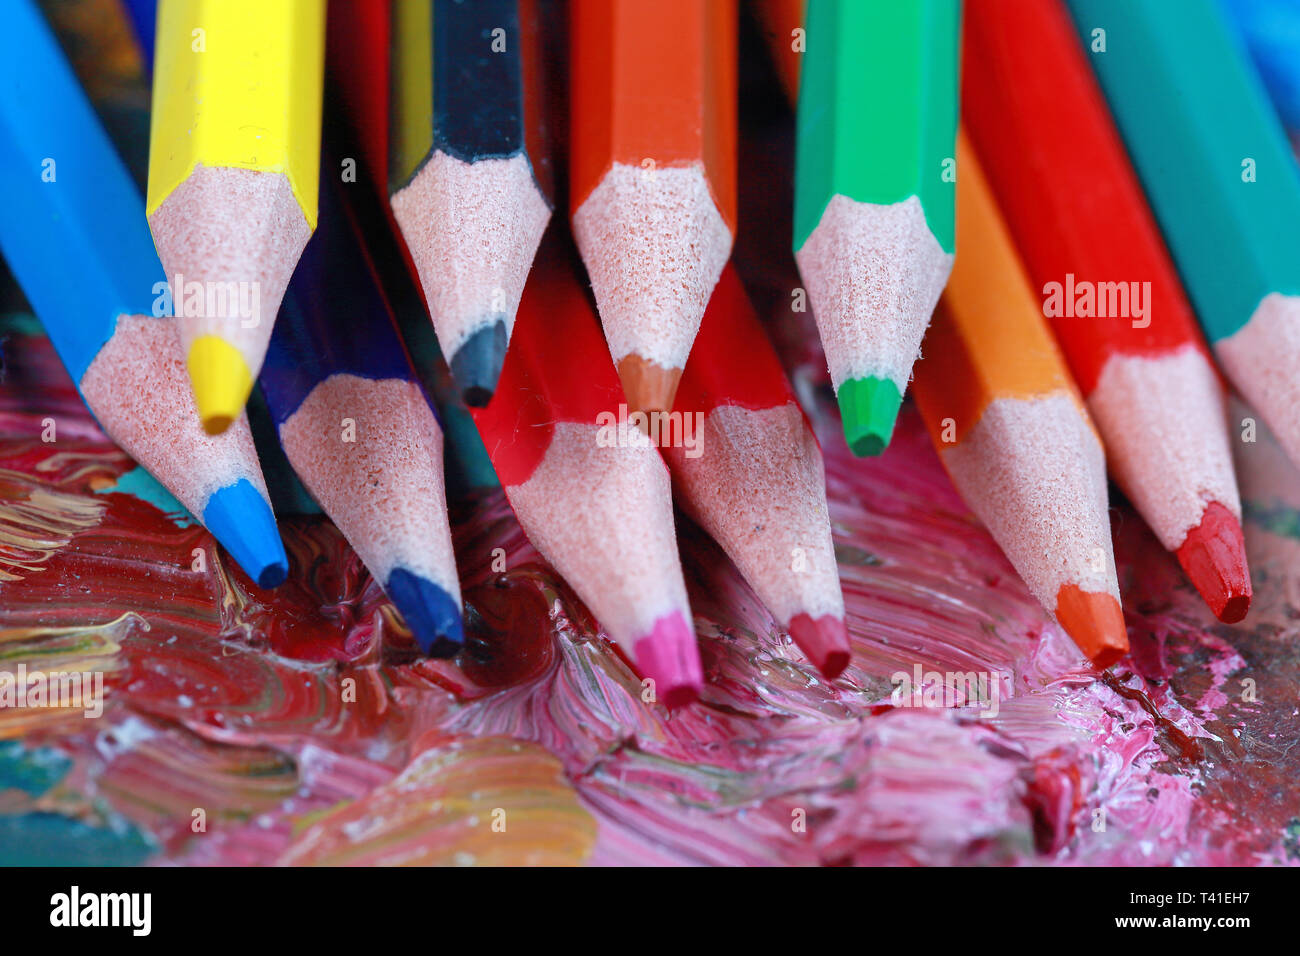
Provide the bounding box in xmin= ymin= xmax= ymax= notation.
xmin=259 ymin=160 xmax=464 ymax=657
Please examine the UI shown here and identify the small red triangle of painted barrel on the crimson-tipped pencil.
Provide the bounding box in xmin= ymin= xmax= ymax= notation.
xmin=673 ymin=264 xmax=794 ymax=414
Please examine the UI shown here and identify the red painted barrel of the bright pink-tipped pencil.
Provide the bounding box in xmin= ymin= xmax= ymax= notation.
xmin=471 ymin=222 xmax=627 ymax=485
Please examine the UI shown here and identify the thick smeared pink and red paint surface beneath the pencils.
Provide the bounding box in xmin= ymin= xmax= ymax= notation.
xmin=0 ymin=321 xmax=1300 ymax=865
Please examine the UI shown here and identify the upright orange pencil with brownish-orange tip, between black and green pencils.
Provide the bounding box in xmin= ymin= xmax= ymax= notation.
xmin=569 ymin=0 xmax=737 ymax=412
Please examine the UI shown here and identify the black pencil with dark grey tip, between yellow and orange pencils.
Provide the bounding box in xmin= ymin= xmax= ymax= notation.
xmin=389 ymin=0 xmax=551 ymax=406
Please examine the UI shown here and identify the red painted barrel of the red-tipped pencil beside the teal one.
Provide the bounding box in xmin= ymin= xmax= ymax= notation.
xmin=962 ymin=0 xmax=1205 ymax=397
